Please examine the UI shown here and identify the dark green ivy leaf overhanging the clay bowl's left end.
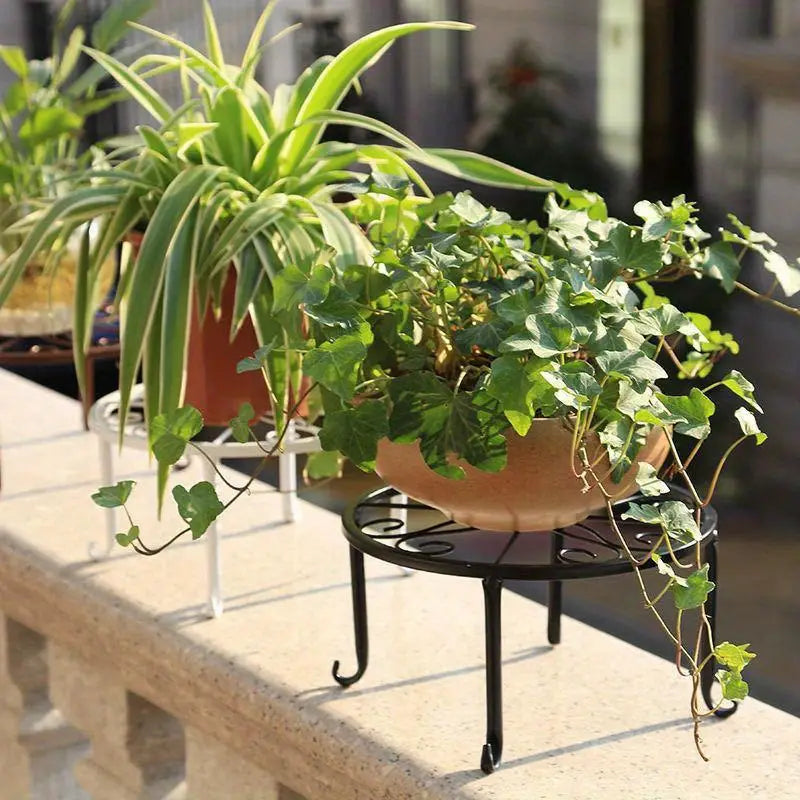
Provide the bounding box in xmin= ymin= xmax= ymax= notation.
xmin=319 ymin=400 xmax=389 ymax=471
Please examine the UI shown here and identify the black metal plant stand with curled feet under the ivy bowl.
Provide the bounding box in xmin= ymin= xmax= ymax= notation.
xmin=333 ymin=487 xmax=736 ymax=774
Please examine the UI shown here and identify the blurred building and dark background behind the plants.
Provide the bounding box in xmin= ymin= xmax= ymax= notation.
xmin=0 ymin=0 xmax=800 ymax=713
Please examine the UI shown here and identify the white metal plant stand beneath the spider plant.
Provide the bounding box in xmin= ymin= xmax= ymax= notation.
xmin=89 ymin=386 xmax=320 ymax=617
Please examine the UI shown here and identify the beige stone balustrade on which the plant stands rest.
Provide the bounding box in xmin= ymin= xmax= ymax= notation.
xmin=0 ymin=371 xmax=800 ymax=800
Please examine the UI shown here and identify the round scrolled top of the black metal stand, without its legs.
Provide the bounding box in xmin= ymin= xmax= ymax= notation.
xmin=342 ymin=486 xmax=717 ymax=580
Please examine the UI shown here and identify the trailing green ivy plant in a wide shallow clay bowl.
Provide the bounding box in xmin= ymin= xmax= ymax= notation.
xmin=94 ymin=175 xmax=800 ymax=758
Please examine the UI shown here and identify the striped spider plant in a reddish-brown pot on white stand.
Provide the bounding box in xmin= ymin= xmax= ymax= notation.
xmin=0 ymin=3 xmax=549 ymax=506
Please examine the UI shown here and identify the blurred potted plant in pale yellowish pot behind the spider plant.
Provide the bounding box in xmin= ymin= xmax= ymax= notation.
xmin=0 ymin=0 xmax=151 ymax=336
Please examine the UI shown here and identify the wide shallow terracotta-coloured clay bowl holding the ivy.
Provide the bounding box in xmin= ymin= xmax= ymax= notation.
xmin=375 ymin=419 xmax=669 ymax=531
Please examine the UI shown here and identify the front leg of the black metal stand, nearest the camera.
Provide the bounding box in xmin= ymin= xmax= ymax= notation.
xmin=481 ymin=578 xmax=503 ymax=775
